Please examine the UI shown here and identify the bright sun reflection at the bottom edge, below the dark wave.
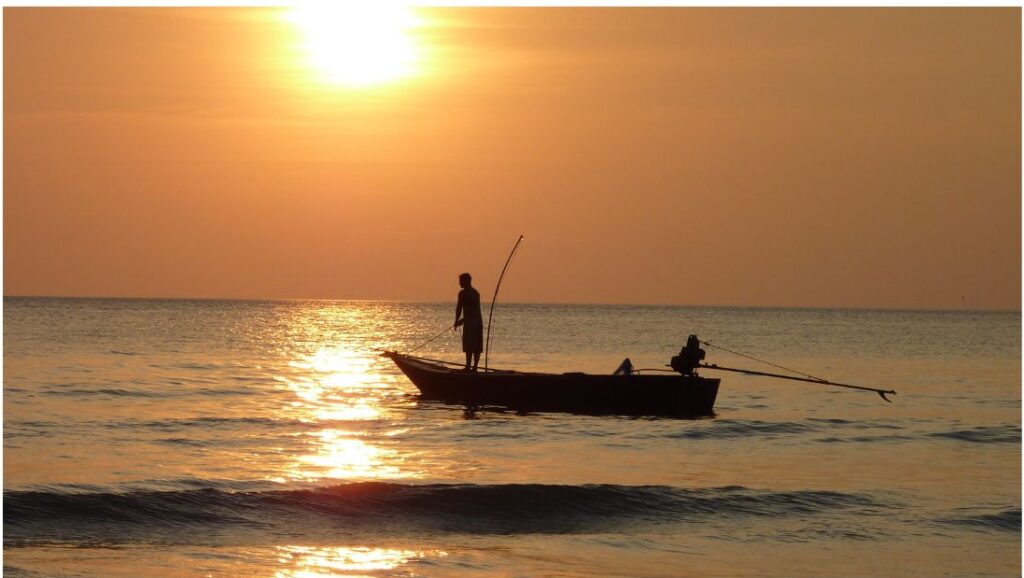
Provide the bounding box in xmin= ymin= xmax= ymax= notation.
xmin=274 ymin=546 xmax=447 ymax=578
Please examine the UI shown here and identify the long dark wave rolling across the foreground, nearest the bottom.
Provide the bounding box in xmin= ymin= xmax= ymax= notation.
xmin=3 ymin=482 xmax=881 ymax=545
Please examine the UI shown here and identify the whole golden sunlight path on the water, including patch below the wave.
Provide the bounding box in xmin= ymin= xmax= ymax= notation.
xmin=260 ymin=305 xmax=449 ymax=578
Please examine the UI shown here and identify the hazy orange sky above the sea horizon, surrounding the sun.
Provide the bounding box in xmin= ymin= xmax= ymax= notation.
xmin=3 ymin=8 xmax=1021 ymax=309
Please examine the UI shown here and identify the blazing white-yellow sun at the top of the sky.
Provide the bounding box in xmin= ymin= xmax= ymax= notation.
xmin=286 ymin=0 xmax=420 ymax=88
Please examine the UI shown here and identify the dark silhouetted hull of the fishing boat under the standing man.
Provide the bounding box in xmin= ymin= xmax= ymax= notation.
xmin=384 ymin=352 xmax=720 ymax=417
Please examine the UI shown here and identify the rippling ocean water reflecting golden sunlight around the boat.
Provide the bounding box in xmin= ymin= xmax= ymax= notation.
xmin=3 ymin=297 xmax=1021 ymax=578
